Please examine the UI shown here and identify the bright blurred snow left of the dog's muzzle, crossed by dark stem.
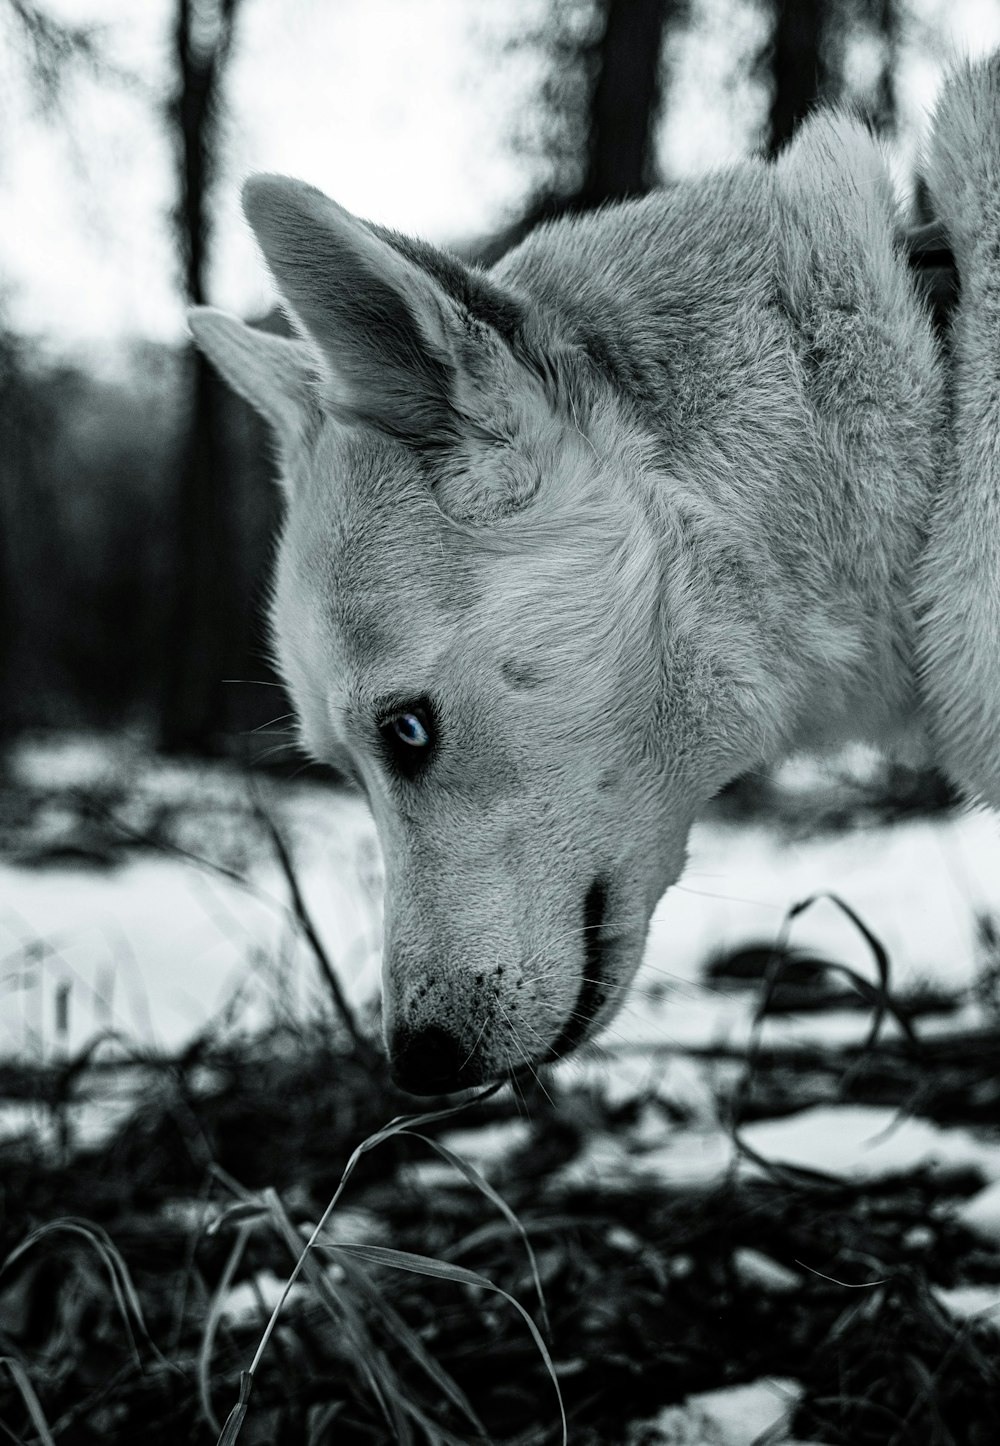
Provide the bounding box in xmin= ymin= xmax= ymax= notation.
xmin=0 ymin=797 xmax=377 ymax=1058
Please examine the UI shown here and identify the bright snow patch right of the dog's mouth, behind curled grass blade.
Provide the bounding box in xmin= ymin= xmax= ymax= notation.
xmin=630 ymin=811 xmax=1000 ymax=1045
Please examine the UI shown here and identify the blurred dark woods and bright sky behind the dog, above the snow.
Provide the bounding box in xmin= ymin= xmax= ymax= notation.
xmin=0 ymin=0 xmax=1000 ymax=758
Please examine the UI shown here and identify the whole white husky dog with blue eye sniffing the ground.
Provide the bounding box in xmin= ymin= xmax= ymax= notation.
xmin=191 ymin=59 xmax=1000 ymax=1093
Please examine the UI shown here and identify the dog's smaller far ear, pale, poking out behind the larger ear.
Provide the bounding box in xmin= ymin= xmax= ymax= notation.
xmin=188 ymin=307 xmax=316 ymax=455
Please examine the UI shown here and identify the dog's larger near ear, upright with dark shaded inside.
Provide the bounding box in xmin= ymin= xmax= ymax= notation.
xmin=243 ymin=175 xmax=461 ymax=441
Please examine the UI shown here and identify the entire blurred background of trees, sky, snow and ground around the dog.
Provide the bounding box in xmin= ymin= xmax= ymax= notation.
xmin=0 ymin=16 xmax=1000 ymax=1446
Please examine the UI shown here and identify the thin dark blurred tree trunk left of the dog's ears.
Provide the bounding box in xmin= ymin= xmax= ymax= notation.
xmin=160 ymin=0 xmax=245 ymax=752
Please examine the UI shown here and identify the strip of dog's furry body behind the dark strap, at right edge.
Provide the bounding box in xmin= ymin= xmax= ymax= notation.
xmin=916 ymin=56 xmax=1000 ymax=807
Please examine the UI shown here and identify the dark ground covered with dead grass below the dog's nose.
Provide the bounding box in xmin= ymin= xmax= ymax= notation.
xmin=0 ymin=763 xmax=1000 ymax=1446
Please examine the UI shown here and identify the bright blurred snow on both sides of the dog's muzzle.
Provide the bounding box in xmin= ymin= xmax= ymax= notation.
xmin=0 ymin=734 xmax=1000 ymax=1058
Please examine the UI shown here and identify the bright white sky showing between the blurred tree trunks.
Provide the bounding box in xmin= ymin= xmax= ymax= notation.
xmin=0 ymin=0 xmax=1000 ymax=350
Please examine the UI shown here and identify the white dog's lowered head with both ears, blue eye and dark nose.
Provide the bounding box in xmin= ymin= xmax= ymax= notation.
xmin=192 ymin=176 xmax=767 ymax=1093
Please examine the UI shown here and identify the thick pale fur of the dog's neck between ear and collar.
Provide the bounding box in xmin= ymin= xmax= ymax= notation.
xmin=497 ymin=143 xmax=944 ymax=766
